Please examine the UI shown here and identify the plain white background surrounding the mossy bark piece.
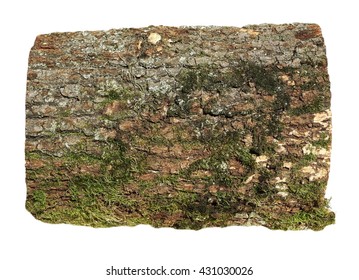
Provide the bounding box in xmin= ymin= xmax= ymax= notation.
xmin=0 ymin=0 xmax=359 ymax=280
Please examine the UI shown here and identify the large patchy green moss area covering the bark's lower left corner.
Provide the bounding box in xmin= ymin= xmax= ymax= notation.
xmin=27 ymin=135 xmax=150 ymax=227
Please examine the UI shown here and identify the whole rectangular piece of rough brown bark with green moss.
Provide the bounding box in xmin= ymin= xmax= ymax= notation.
xmin=26 ymin=24 xmax=334 ymax=230
